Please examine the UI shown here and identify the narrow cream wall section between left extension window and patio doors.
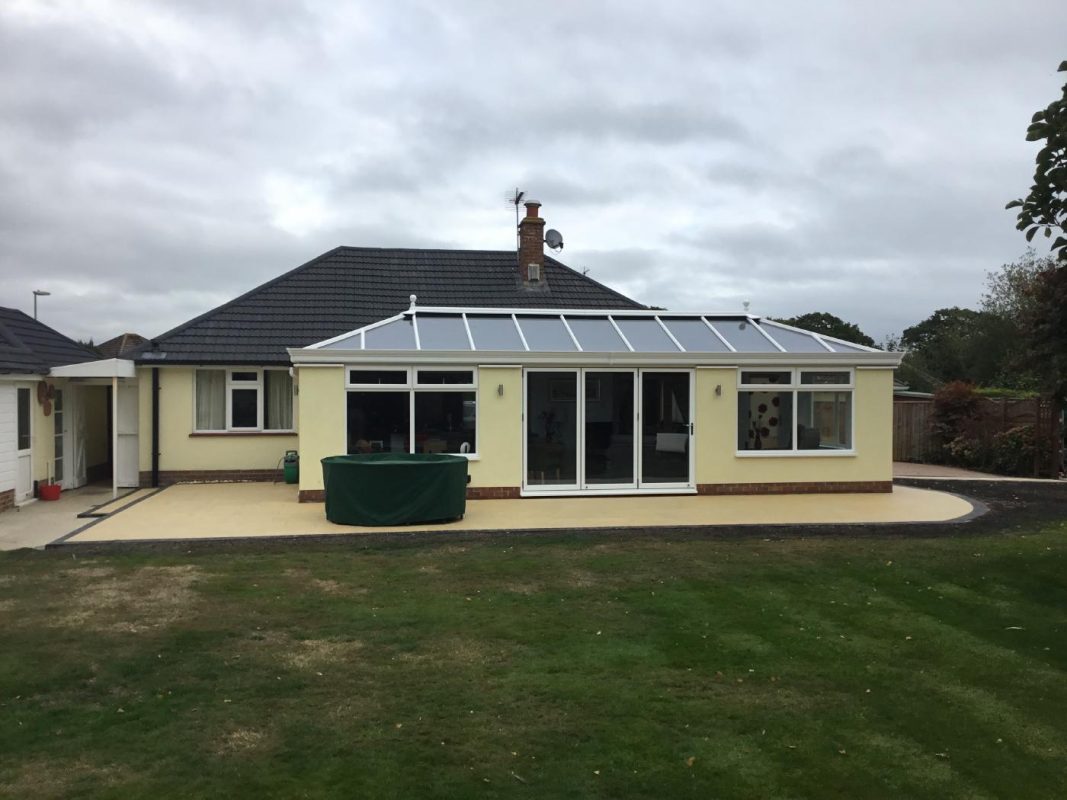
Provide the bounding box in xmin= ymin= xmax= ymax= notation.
xmin=468 ymin=367 xmax=523 ymax=486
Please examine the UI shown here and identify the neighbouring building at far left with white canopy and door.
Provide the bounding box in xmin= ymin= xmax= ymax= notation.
xmin=0 ymin=308 xmax=137 ymax=511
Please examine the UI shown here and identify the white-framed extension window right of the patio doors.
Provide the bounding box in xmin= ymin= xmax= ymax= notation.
xmin=737 ymin=367 xmax=856 ymax=455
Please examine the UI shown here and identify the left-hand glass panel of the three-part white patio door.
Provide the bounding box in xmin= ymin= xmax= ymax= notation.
xmin=526 ymin=371 xmax=578 ymax=490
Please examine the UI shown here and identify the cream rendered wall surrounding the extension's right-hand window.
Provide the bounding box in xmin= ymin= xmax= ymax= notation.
xmin=695 ymin=367 xmax=893 ymax=483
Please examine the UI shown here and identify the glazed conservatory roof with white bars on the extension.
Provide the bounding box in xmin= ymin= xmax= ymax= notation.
xmin=289 ymin=300 xmax=899 ymax=366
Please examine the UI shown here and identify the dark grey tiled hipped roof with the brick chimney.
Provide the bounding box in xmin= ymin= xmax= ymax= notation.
xmin=133 ymin=247 xmax=643 ymax=364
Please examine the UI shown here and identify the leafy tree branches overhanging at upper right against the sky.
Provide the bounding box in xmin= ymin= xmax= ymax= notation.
xmin=1006 ymin=61 xmax=1067 ymax=266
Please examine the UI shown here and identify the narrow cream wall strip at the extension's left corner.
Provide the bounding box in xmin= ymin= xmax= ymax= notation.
xmin=297 ymin=367 xmax=348 ymax=491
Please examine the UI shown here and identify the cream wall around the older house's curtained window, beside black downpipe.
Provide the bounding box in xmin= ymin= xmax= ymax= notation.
xmin=138 ymin=367 xmax=297 ymax=471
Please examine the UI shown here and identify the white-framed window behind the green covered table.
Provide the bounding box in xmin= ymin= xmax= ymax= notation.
xmin=345 ymin=367 xmax=478 ymax=458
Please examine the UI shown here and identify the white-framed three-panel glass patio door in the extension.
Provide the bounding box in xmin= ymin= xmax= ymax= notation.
xmin=523 ymin=369 xmax=694 ymax=494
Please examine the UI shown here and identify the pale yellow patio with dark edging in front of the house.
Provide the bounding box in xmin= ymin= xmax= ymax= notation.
xmin=56 ymin=483 xmax=974 ymax=544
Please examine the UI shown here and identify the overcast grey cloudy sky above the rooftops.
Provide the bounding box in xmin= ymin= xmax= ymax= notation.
xmin=0 ymin=0 xmax=1067 ymax=341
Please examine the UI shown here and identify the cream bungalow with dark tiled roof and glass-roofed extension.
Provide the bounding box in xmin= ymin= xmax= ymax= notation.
xmin=132 ymin=203 xmax=899 ymax=500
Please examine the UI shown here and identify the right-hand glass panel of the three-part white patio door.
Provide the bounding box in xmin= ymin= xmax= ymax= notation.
xmin=641 ymin=371 xmax=691 ymax=485
